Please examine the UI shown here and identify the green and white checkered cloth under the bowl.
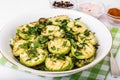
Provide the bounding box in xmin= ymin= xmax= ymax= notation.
xmin=0 ymin=28 xmax=120 ymax=80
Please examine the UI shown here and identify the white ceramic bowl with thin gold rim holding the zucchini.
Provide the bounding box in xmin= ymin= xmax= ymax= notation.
xmin=0 ymin=9 xmax=112 ymax=77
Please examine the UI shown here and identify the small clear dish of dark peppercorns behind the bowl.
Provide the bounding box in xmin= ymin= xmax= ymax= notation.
xmin=50 ymin=0 xmax=75 ymax=9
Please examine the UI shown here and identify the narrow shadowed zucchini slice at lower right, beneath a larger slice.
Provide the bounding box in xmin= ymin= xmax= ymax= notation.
xmin=75 ymin=56 xmax=94 ymax=67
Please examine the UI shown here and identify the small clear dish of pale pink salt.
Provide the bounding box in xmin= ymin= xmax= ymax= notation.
xmin=77 ymin=1 xmax=104 ymax=18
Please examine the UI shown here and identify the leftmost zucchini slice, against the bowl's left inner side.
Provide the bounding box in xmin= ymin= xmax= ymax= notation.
xmin=13 ymin=40 xmax=26 ymax=56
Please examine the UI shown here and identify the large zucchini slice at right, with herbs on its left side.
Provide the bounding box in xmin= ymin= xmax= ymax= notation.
xmin=71 ymin=43 xmax=96 ymax=59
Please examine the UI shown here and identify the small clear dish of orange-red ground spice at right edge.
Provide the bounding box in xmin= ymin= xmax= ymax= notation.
xmin=107 ymin=7 xmax=120 ymax=24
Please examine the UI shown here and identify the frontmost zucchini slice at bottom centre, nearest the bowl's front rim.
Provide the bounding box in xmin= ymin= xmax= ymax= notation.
xmin=45 ymin=56 xmax=73 ymax=71
